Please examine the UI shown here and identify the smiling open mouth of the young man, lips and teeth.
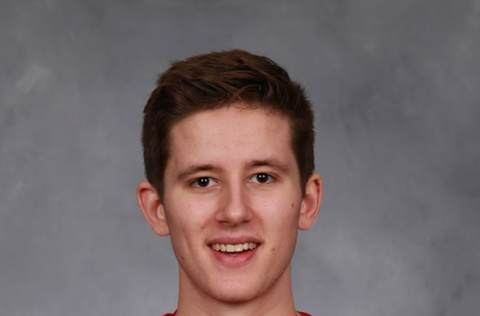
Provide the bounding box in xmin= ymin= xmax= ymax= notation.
xmin=209 ymin=240 xmax=260 ymax=268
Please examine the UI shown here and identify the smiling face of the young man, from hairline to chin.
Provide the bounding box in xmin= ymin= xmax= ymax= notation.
xmin=149 ymin=105 xmax=316 ymax=303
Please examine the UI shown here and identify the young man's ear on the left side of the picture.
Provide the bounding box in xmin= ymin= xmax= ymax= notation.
xmin=137 ymin=181 xmax=169 ymax=236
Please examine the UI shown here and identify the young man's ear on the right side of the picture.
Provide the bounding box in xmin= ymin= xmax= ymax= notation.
xmin=298 ymin=173 xmax=323 ymax=230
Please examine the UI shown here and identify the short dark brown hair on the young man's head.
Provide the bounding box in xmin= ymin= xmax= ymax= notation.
xmin=142 ymin=49 xmax=314 ymax=196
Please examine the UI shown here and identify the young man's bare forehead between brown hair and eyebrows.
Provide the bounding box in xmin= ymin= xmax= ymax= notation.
xmin=169 ymin=105 xmax=293 ymax=168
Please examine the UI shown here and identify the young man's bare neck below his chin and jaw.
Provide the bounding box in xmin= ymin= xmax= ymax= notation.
xmin=176 ymin=266 xmax=297 ymax=316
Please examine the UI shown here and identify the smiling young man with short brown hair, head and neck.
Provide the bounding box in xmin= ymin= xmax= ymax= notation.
xmin=137 ymin=50 xmax=322 ymax=316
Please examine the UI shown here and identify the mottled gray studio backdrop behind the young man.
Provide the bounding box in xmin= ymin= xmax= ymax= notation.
xmin=0 ymin=0 xmax=480 ymax=316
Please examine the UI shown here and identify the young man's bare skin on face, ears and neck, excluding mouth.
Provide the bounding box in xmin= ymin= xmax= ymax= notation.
xmin=137 ymin=104 xmax=322 ymax=316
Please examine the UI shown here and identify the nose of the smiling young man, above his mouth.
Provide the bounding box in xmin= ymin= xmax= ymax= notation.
xmin=216 ymin=180 xmax=252 ymax=226
